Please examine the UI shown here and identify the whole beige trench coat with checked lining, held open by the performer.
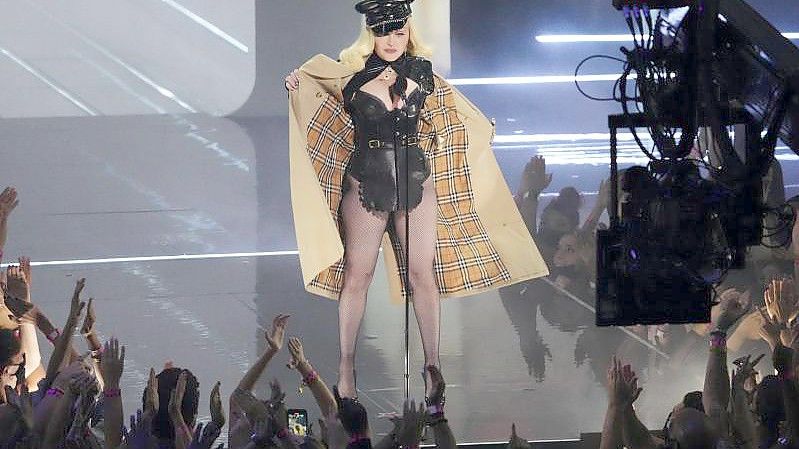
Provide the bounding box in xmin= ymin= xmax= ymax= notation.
xmin=289 ymin=55 xmax=548 ymax=301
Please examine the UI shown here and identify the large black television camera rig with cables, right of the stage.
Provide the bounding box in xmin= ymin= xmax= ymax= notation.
xmin=596 ymin=0 xmax=799 ymax=326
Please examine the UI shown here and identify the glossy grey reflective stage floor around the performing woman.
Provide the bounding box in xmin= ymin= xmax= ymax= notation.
xmin=0 ymin=101 xmax=799 ymax=442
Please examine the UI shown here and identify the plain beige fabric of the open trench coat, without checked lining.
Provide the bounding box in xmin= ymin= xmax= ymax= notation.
xmin=289 ymin=55 xmax=549 ymax=301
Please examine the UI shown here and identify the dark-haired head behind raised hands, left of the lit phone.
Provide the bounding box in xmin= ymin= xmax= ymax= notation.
xmin=147 ymin=368 xmax=200 ymax=441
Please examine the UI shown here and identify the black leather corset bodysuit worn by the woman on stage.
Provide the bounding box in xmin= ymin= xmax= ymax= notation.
xmin=344 ymin=56 xmax=430 ymax=212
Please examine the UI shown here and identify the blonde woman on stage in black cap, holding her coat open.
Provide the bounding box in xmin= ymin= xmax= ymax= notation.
xmin=286 ymin=0 xmax=547 ymax=398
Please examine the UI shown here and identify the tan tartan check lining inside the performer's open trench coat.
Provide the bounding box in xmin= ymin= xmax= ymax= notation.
xmin=307 ymin=77 xmax=511 ymax=297
